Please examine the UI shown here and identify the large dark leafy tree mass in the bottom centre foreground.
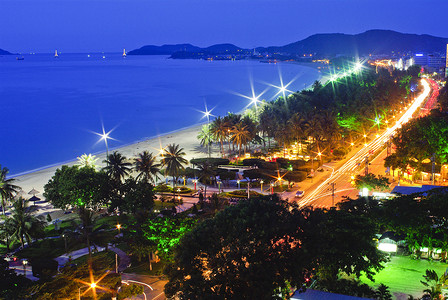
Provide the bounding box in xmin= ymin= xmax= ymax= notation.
xmin=165 ymin=196 xmax=384 ymax=299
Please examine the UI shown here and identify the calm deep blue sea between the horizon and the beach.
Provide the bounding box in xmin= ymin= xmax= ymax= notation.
xmin=0 ymin=53 xmax=320 ymax=174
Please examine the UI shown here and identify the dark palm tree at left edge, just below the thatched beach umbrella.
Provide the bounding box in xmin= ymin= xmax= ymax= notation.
xmin=5 ymin=198 xmax=45 ymax=247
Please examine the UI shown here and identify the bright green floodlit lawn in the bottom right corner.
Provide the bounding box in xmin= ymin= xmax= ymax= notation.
xmin=361 ymin=256 xmax=447 ymax=297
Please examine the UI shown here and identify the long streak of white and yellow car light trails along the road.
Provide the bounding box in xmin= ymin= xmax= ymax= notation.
xmin=299 ymin=79 xmax=431 ymax=207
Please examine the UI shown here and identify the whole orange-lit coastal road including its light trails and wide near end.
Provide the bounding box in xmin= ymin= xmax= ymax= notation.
xmin=283 ymin=79 xmax=431 ymax=208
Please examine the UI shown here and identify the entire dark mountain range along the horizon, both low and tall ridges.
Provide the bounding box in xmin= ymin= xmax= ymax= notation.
xmin=128 ymin=29 xmax=448 ymax=59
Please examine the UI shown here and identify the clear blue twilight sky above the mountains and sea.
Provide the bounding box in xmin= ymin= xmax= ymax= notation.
xmin=0 ymin=0 xmax=448 ymax=52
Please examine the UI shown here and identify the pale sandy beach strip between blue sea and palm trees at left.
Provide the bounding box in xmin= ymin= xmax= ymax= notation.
xmin=14 ymin=125 xmax=207 ymax=198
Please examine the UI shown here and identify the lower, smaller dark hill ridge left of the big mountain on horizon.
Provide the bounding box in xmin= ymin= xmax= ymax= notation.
xmin=127 ymin=44 xmax=244 ymax=55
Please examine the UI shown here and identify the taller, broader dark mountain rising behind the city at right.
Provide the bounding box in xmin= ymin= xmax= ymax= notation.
xmin=257 ymin=30 xmax=448 ymax=56
